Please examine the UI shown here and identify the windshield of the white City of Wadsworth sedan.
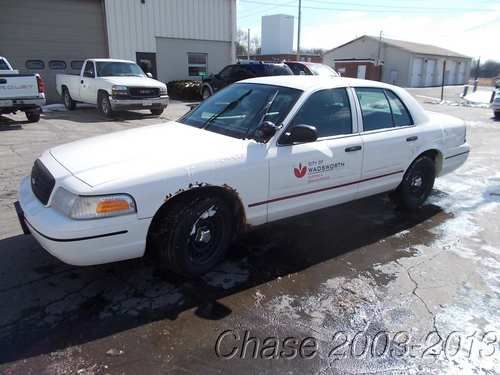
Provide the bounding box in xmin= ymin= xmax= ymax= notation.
xmin=179 ymin=83 xmax=302 ymax=139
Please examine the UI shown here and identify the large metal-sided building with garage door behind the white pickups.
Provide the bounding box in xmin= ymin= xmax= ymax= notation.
xmin=0 ymin=0 xmax=236 ymax=101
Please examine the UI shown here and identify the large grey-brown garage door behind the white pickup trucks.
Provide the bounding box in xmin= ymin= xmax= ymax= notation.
xmin=0 ymin=0 xmax=108 ymax=101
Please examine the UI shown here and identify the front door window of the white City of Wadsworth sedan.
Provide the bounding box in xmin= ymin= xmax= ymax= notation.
xmin=292 ymin=88 xmax=352 ymax=138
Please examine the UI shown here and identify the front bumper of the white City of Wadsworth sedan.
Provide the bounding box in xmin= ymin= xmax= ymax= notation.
xmin=16 ymin=177 xmax=151 ymax=266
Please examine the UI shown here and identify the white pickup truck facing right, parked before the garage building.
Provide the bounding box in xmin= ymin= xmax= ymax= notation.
xmin=56 ymin=59 xmax=168 ymax=117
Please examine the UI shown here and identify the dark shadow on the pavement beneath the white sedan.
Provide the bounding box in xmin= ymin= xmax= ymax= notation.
xmin=0 ymin=196 xmax=449 ymax=364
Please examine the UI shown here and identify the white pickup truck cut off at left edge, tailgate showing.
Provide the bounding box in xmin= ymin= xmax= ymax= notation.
xmin=0 ymin=56 xmax=45 ymax=122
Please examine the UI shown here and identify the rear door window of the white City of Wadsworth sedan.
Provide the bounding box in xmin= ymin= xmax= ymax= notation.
xmin=356 ymin=88 xmax=394 ymax=131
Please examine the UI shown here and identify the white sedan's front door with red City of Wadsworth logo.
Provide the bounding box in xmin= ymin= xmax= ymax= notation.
xmin=267 ymin=88 xmax=363 ymax=221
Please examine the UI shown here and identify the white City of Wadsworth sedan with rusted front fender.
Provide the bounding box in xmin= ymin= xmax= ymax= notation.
xmin=18 ymin=76 xmax=469 ymax=276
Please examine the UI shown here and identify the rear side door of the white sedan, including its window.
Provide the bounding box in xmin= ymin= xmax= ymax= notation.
xmin=354 ymin=87 xmax=418 ymax=196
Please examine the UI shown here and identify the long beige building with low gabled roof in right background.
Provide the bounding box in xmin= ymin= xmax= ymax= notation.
xmin=323 ymin=35 xmax=472 ymax=87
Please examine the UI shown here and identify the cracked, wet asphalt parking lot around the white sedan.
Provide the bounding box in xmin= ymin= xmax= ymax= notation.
xmin=0 ymin=88 xmax=500 ymax=374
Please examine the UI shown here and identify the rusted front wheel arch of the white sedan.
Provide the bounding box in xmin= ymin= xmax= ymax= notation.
xmin=146 ymin=186 xmax=246 ymax=254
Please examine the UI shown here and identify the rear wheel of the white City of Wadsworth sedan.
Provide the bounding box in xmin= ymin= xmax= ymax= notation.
xmin=390 ymin=156 xmax=436 ymax=212
